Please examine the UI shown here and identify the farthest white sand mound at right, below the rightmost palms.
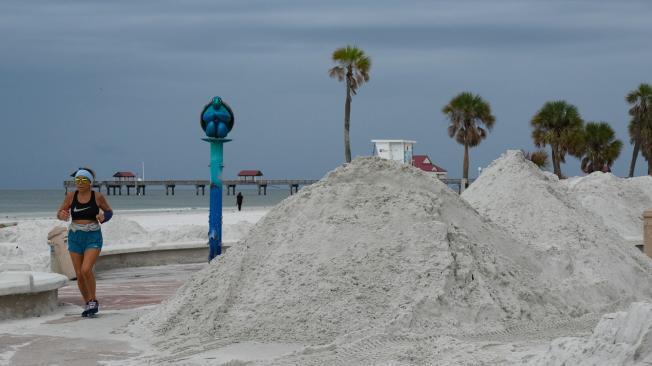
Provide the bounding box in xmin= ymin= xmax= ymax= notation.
xmin=561 ymin=172 xmax=652 ymax=245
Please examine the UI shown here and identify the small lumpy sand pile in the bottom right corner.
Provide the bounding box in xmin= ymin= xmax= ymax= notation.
xmin=530 ymin=303 xmax=652 ymax=366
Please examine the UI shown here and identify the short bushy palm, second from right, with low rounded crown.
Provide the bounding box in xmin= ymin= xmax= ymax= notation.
xmin=581 ymin=122 xmax=623 ymax=173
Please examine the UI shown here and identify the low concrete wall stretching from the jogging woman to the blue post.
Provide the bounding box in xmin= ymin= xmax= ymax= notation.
xmin=95 ymin=243 xmax=229 ymax=271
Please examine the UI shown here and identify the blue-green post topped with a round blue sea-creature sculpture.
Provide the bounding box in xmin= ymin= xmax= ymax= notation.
xmin=200 ymin=97 xmax=234 ymax=262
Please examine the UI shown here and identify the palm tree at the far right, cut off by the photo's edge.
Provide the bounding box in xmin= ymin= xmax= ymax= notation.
xmin=625 ymin=83 xmax=652 ymax=177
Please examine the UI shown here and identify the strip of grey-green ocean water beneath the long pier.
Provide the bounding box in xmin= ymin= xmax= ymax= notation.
xmin=0 ymin=187 xmax=290 ymax=219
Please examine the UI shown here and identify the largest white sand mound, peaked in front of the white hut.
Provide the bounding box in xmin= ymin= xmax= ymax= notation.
xmin=136 ymin=158 xmax=568 ymax=349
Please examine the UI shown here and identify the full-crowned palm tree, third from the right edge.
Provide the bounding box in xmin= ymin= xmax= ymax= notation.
xmin=530 ymin=100 xmax=584 ymax=178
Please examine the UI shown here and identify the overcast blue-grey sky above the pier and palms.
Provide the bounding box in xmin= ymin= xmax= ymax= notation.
xmin=0 ymin=0 xmax=652 ymax=189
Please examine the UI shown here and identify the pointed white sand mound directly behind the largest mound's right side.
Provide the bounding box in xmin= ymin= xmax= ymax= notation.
xmin=462 ymin=151 xmax=652 ymax=314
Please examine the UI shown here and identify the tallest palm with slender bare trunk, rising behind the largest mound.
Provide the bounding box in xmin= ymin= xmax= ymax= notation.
xmin=328 ymin=46 xmax=371 ymax=163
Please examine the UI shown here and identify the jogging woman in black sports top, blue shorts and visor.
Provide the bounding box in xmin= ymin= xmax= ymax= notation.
xmin=57 ymin=168 xmax=113 ymax=317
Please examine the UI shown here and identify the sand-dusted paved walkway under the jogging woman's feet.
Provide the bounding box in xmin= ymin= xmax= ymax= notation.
xmin=0 ymin=264 xmax=206 ymax=366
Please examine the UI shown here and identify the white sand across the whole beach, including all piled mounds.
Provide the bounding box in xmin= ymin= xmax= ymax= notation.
xmin=0 ymin=151 xmax=652 ymax=366
